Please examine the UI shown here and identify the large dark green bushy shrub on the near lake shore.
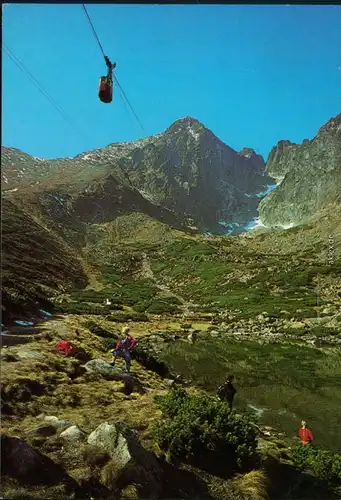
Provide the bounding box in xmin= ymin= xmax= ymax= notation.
xmin=154 ymin=388 xmax=257 ymax=474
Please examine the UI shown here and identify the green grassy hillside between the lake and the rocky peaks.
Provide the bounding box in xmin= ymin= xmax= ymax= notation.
xmin=77 ymin=218 xmax=341 ymax=317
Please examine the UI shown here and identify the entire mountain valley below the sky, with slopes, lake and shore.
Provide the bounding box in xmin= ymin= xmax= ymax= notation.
xmin=1 ymin=114 xmax=341 ymax=500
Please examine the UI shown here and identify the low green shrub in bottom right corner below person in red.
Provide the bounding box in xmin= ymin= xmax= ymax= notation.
xmin=293 ymin=445 xmax=341 ymax=482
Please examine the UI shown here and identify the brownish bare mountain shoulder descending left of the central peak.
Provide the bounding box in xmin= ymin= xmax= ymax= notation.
xmin=3 ymin=152 xmax=191 ymax=247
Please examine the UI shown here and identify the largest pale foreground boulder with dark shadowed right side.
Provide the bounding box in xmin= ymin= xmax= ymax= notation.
xmin=88 ymin=422 xmax=163 ymax=498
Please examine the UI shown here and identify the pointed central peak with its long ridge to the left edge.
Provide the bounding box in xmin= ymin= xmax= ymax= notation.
xmin=2 ymin=118 xmax=271 ymax=232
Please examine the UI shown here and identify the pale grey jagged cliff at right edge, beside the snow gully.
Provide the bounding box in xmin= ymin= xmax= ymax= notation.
xmin=259 ymin=114 xmax=341 ymax=226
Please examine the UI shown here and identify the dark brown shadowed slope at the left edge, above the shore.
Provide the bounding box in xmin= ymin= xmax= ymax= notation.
xmin=1 ymin=199 xmax=87 ymax=323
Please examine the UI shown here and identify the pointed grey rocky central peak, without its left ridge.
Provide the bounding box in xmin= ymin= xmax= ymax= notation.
xmin=114 ymin=118 xmax=271 ymax=230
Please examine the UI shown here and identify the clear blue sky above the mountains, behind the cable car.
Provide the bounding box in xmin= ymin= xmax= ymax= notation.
xmin=2 ymin=4 xmax=341 ymax=158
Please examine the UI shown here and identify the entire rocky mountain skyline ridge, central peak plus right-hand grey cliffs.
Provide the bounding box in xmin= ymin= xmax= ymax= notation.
xmin=2 ymin=114 xmax=341 ymax=233
